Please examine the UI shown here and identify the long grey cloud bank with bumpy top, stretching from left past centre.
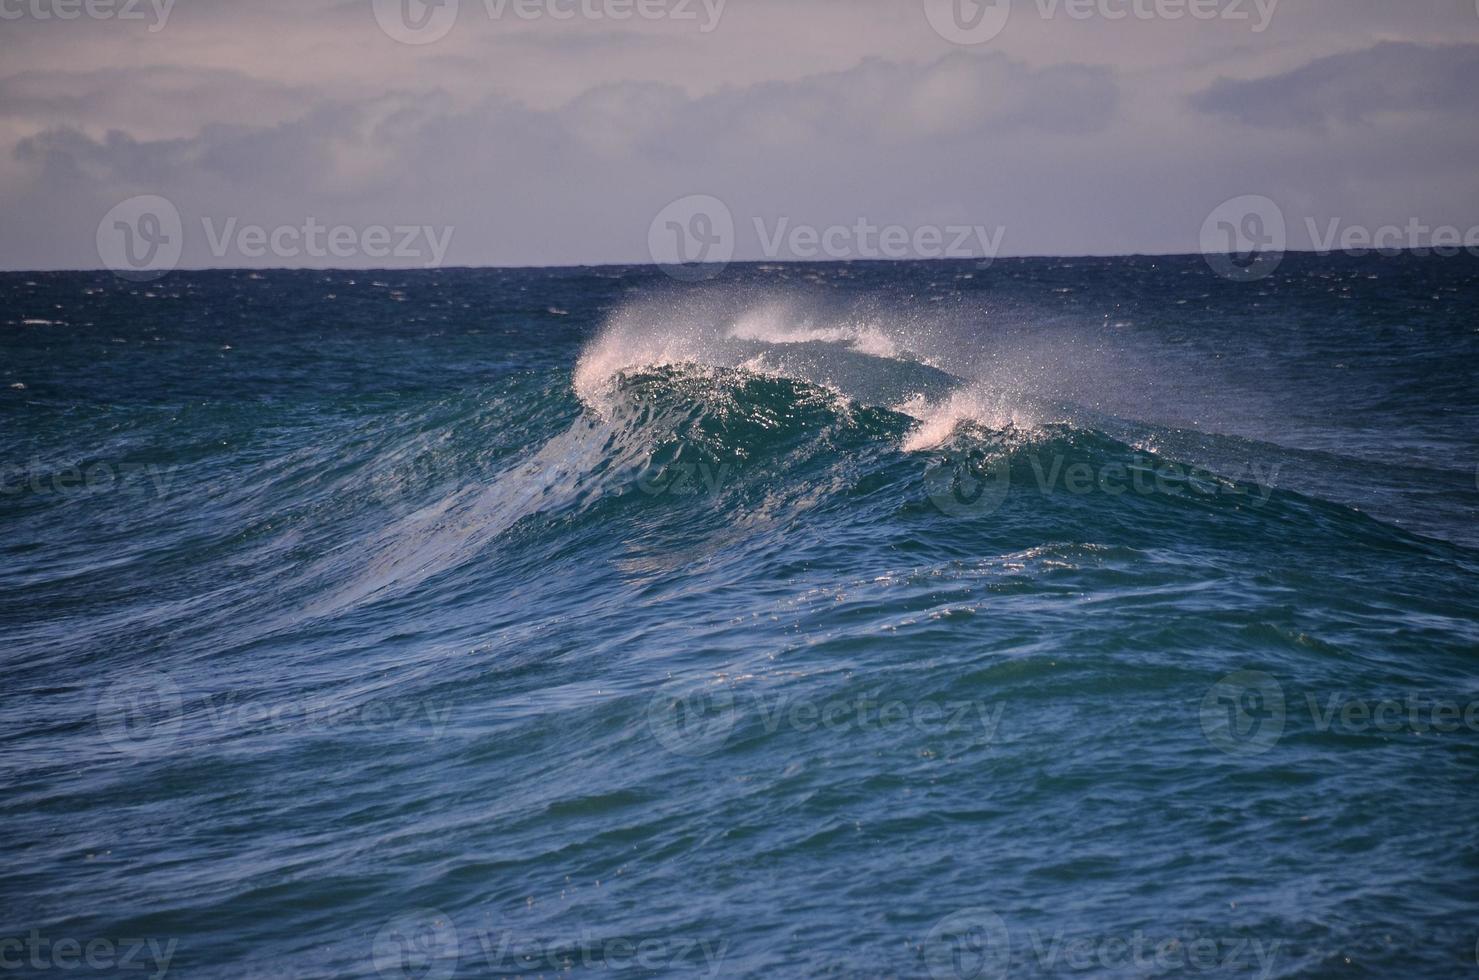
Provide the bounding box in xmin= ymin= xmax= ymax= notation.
xmin=2 ymin=52 xmax=1117 ymax=263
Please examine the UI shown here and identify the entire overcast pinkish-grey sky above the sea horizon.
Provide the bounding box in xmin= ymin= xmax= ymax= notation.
xmin=0 ymin=0 xmax=1479 ymax=269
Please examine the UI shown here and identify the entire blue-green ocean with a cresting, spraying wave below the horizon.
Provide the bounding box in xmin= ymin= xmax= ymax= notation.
xmin=0 ymin=256 xmax=1479 ymax=977
